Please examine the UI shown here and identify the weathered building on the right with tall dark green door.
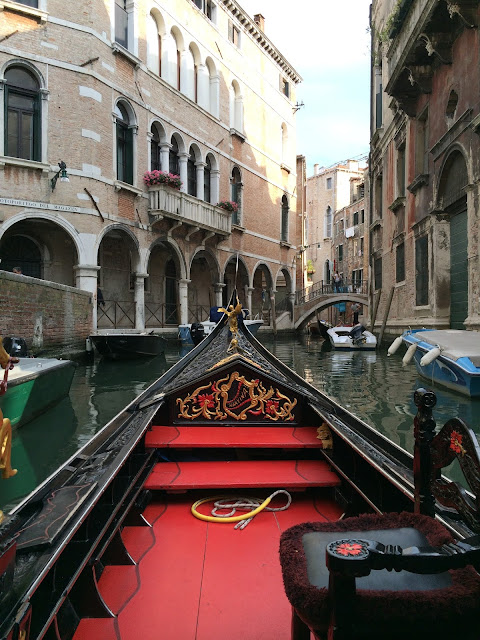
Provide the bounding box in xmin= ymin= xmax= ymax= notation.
xmin=369 ymin=0 xmax=480 ymax=333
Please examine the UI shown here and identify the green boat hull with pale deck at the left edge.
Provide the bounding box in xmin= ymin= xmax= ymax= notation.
xmin=0 ymin=358 xmax=75 ymax=427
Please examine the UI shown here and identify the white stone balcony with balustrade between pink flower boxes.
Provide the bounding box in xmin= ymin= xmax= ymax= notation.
xmin=148 ymin=184 xmax=232 ymax=239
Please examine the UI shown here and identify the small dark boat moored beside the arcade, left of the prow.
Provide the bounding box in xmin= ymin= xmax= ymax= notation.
xmin=90 ymin=332 xmax=167 ymax=360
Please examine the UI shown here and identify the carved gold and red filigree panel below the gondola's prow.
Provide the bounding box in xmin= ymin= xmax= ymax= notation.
xmin=177 ymin=371 xmax=297 ymax=422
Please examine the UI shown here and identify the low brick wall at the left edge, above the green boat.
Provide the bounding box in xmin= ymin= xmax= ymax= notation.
xmin=0 ymin=271 xmax=92 ymax=354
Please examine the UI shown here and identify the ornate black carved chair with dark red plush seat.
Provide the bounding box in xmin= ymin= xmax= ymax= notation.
xmin=280 ymin=390 xmax=480 ymax=640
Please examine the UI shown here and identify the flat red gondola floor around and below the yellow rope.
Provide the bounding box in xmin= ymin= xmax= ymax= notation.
xmin=73 ymin=493 xmax=338 ymax=640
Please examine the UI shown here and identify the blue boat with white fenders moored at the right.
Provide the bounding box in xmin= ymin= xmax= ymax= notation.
xmin=402 ymin=329 xmax=480 ymax=398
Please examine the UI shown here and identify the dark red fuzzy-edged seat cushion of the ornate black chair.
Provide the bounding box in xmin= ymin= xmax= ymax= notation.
xmin=280 ymin=513 xmax=480 ymax=640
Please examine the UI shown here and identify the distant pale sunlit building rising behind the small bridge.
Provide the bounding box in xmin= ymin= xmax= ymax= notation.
xmin=306 ymin=160 xmax=363 ymax=292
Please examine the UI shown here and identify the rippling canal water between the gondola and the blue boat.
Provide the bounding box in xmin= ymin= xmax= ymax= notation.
xmin=262 ymin=336 xmax=480 ymax=452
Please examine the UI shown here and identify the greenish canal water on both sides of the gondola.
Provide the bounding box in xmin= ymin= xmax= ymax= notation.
xmin=0 ymin=334 xmax=480 ymax=512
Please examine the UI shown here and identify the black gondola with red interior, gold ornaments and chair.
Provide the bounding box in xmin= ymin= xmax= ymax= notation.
xmin=0 ymin=299 xmax=480 ymax=640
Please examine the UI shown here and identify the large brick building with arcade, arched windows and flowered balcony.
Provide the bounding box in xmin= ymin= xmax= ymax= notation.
xmin=0 ymin=0 xmax=301 ymax=330
